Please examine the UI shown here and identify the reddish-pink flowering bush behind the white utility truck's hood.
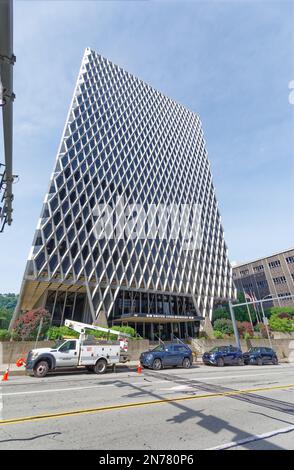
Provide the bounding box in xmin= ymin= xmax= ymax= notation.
xmin=13 ymin=308 xmax=51 ymax=341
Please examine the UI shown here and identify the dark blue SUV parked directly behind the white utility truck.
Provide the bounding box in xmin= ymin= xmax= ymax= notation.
xmin=140 ymin=343 xmax=193 ymax=370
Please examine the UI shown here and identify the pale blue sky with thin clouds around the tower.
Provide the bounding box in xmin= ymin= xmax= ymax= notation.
xmin=0 ymin=0 xmax=294 ymax=292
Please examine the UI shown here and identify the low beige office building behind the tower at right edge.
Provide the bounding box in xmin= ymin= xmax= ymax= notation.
xmin=233 ymin=249 xmax=294 ymax=308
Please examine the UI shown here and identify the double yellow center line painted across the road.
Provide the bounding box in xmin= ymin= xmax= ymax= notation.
xmin=0 ymin=384 xmax=294 ymax=426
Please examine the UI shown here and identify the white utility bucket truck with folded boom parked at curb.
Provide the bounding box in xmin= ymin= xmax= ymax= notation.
xmin=26 ymin=320 xmax=130 ymax=377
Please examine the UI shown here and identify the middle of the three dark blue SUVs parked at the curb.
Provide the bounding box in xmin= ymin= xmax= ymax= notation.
xmin=202 ymin=346 xmax=244 ymax=367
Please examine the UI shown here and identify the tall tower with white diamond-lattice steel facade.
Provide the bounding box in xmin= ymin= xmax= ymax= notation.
xmin=16 ymin=49 xmax=234 ymax=339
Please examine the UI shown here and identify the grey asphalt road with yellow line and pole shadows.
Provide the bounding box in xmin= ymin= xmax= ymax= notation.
xmin=0 ymin=364 xmax=294 ymax=450
